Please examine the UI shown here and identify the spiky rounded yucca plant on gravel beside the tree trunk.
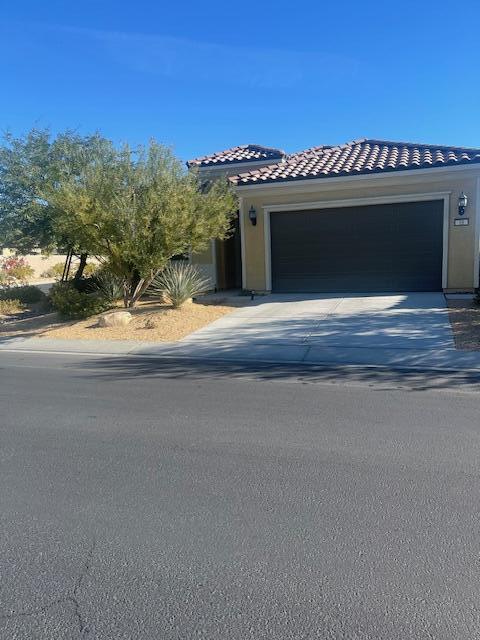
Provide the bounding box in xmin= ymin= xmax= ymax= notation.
xmin=149 ymin=262 xmax=212 ymax=309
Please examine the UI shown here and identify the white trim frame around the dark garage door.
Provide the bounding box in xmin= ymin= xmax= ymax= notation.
xmin=262 ymin=191 xmax=452 ymax=291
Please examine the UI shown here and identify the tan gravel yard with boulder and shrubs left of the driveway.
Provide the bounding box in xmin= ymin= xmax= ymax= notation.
xmin=0 ymin=297 xmax=244 ymax=342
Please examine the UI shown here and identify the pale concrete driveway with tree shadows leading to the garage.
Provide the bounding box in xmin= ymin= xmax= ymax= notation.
xmin=154 ymin=293 xmax=480 ymax=367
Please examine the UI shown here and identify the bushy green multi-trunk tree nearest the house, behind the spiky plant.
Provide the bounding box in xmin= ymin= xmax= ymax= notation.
xmin=46 ymin=142 xmax=237 ymax=307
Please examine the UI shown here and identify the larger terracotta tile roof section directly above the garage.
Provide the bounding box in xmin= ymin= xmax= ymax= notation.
xmin=230 ymin=139 xmax=480 ymax=186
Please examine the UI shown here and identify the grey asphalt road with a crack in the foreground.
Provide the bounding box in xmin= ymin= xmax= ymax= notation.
xmin=0 ymin=353 xmax=480 ymax=640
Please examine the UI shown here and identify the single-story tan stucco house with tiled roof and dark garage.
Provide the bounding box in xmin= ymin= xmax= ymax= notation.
xmin=187 ymin=139 xmax=480 ymax=293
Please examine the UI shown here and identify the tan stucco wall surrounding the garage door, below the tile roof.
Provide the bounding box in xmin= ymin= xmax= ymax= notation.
xmin=238 ymin=169 xmax=480 ymax=291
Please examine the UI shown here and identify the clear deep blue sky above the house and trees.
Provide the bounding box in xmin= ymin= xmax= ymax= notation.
xmin=0 ymin=0 xmax=480 ymax=164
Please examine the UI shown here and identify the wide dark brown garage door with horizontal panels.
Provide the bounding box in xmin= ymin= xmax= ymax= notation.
xmin=270 ymin=201 xmax=443 ymax=292
